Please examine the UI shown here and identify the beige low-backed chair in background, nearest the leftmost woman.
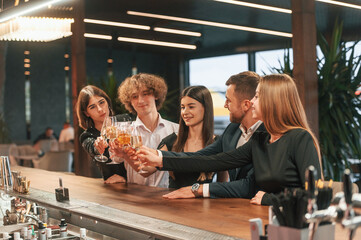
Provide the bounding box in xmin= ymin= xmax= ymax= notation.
xmin=33 ymin=151 xmax=73 ymax=172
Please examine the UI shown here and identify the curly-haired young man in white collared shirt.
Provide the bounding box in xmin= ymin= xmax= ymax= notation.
xmin=112 ymin=73 xmax=178 ymax=187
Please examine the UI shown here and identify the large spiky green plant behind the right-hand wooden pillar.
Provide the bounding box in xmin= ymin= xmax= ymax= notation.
xmin=272 ymin=20 xmax=361 ymax=181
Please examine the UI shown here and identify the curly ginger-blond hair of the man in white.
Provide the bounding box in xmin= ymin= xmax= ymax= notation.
xmin=118 ymin=73 xmax=168 ymax=114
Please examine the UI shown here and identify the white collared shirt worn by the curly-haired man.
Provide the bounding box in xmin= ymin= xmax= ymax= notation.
xmin=124 ymin=114 xmax=178 ymax=188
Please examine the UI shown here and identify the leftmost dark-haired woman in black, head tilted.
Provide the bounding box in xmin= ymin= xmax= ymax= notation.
xmin=76 ymin=85 xmax=127 ymax=184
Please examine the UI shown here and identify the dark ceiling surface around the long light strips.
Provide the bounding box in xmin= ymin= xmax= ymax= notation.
xmin=0 ymin=0 xmax=361 ymax=58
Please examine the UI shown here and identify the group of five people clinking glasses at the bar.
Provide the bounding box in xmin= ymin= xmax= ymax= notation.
xmin=76 ymin=71 xmax=322 ymax=205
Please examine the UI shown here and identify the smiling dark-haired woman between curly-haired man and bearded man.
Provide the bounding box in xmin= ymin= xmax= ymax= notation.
xmin=158 ymin=86 xmax=228 ymax=188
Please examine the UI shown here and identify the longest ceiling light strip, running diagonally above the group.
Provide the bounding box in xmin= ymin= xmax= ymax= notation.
xmin=127 ymin=11 xmax=292 ymax=38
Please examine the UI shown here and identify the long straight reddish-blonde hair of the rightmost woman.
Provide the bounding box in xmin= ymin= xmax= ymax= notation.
xmin=259 ymin=74 xmax=323 ymax=176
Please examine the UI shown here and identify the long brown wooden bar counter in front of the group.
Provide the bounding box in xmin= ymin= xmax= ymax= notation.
xmin=5 ymin=166 xmax=361 ymax=239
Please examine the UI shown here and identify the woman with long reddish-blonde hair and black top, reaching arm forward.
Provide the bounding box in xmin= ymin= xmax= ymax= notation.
xmin=137 ymin=74 xmax=322 ymax=205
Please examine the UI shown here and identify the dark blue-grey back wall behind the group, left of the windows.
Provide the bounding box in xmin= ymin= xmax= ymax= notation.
xmin=4 ymin=40 xmax=180 ymax=142
